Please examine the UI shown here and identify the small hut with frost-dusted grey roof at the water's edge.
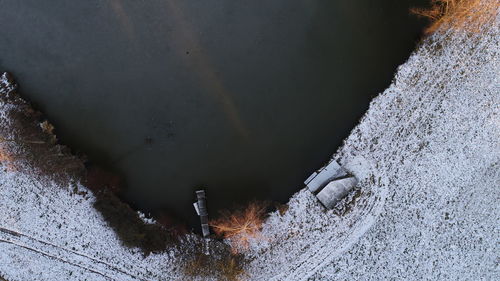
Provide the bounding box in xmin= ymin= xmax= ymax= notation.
xmin=304 ymin=160 xmax=358 ymax=209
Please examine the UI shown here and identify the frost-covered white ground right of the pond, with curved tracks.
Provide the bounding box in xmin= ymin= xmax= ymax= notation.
xmin=244 ymin=23 xmax=500 ymax=280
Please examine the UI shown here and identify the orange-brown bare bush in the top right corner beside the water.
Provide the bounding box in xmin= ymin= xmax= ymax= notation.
xmin=411 ymin=0 xmax=500 ymax=34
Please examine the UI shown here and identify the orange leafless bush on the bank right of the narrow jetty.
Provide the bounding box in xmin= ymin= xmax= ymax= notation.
xmin=210 ymin=202 xmax=266 ymax=253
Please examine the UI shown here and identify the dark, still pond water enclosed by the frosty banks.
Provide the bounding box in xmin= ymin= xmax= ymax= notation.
xmin=0 ymin=0 xmax=426 ymax=226
